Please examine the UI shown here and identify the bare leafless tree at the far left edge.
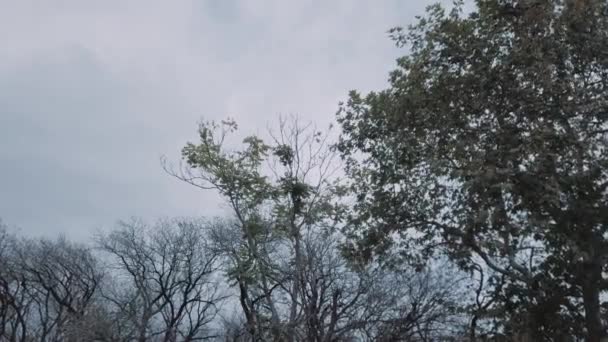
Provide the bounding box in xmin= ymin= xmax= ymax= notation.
xmin=0 ymin=222 xmax=103 ymax=342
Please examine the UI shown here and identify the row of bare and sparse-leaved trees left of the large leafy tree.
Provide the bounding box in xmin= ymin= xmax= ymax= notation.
xmin=0 ymin=118 xmax=464 ymax=342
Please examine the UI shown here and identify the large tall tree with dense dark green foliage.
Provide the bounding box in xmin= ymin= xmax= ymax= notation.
xmin=338 ymin=0 xmax=608 ymax=342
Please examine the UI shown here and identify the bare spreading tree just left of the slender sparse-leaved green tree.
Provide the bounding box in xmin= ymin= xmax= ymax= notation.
xmin=97 ymin=220 xmax=224 ymax=342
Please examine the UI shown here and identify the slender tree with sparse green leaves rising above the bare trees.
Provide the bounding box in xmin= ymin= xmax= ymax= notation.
xmin=166 ymin=118 xmax=340 ymax=340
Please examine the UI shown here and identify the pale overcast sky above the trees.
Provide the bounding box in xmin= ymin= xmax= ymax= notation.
xmin=0 ymin=0 xmax=452 ymax=238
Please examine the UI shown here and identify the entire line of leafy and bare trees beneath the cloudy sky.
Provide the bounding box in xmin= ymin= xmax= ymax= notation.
xmin=0 ymin=0 xmax=608 ymax=342
